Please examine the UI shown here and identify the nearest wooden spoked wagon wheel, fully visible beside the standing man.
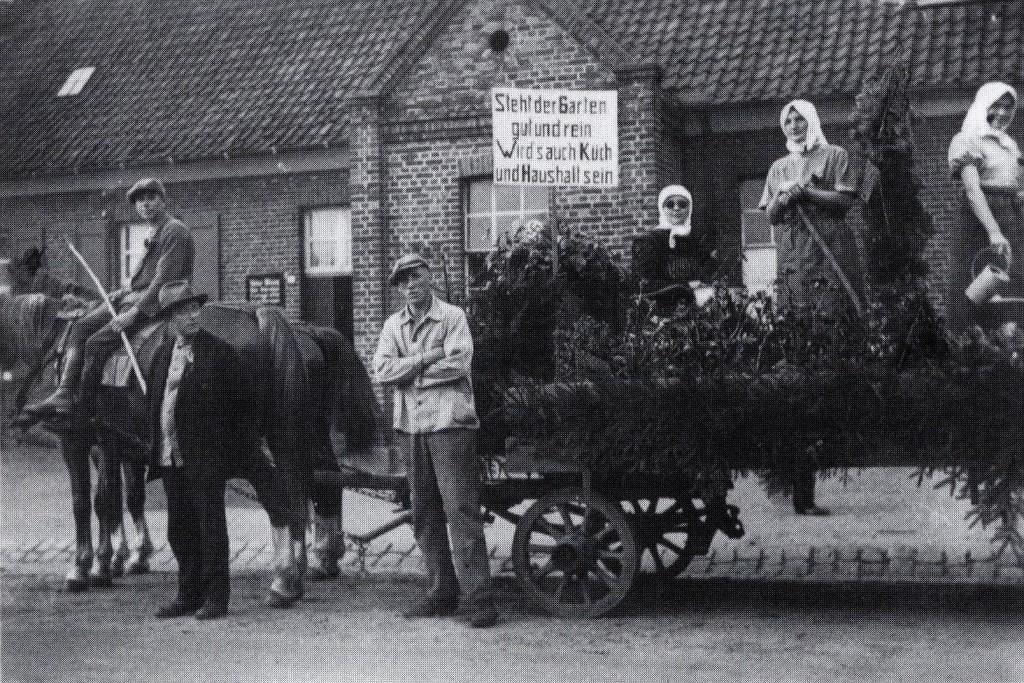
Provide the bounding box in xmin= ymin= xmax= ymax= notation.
xmin=512 ymin=487 xmax=639 ymax=617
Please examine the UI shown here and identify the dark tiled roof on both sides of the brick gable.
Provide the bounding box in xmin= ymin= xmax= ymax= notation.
xmin=0 ymin=0 xmax=1024 ymax=177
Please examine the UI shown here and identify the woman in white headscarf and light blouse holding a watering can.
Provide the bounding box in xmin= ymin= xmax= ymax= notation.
xmin=949 ymin=82 xmax=1024 ymax=325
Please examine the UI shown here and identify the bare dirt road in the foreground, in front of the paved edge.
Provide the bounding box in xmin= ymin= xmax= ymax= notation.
xmin=3 ymin=574 xmax=1024 ymax=683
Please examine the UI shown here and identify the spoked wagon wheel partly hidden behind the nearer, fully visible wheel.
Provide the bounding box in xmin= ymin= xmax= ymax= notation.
xmin=623 ymin=498 xmax=715 ymax=578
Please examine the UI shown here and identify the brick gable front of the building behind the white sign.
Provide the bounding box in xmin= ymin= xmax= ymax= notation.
xmin=351 ymin=0 xmax=681 ymax=357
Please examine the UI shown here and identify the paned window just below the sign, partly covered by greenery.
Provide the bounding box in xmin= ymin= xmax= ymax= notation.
xmin=464 ymin=178 xmax=548 ymax=284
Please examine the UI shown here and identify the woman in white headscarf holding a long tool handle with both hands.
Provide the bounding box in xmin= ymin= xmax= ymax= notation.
xmin=761 ymin=99 xmax=859 ymax=313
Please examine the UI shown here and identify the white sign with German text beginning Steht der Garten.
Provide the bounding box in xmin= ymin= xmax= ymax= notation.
xmin=490 ymin=88 xmax=618 ymax=187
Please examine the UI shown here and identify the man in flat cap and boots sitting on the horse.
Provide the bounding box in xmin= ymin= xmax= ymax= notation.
xmin=24 ymin=178 xmax=196 ymax=422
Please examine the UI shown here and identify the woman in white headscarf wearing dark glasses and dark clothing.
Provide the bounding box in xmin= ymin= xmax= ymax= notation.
xmin=633 ymin=185 xmax=715 ymax=315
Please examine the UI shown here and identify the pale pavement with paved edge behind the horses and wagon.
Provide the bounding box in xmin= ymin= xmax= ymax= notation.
xmin=6 ymin=436 xmax=1024 ymax=585
